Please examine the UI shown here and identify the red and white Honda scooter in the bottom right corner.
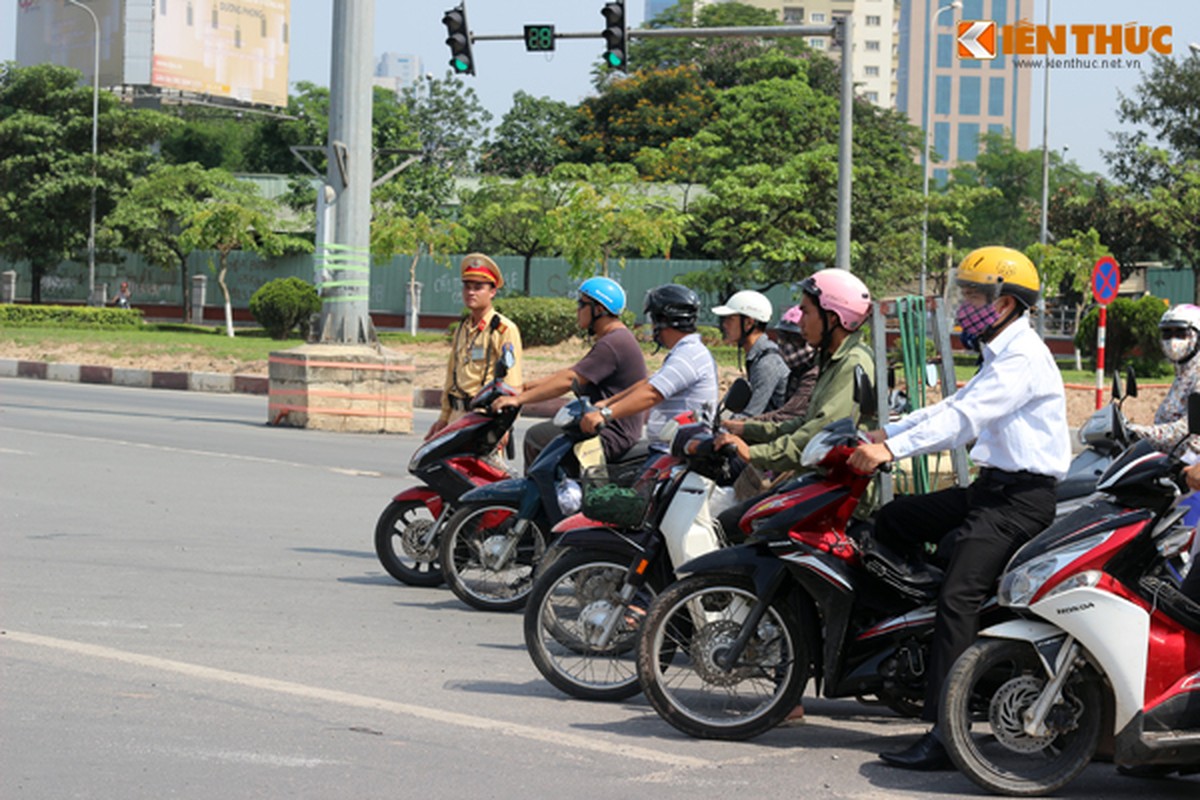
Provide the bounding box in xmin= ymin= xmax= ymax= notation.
xmin=940 ymin=410 xmax=1200 ymax=796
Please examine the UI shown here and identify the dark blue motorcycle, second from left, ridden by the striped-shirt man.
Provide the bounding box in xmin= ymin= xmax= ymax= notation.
xmin=439 ymin=387 xmax=649 ymax=610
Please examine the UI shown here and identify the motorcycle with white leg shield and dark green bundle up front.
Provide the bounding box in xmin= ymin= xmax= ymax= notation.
xmin=524 ymin=379 xmax=751 ymax=700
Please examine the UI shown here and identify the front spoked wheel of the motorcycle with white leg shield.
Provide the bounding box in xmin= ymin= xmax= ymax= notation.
xmin=524 ymin=551 xmax=649 ymax=700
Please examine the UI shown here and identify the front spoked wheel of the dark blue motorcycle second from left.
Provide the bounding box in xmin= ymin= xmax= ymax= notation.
xmin=439 ymin=503 xmax=546 ymax=610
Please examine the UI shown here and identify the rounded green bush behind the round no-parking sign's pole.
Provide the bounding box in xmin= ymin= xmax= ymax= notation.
xmin=1075 ymin=295 xmax=1166 ymax=375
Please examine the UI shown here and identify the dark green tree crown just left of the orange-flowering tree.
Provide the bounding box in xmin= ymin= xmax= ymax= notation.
xmin=481 ymin=91 xmax=575 ymax=178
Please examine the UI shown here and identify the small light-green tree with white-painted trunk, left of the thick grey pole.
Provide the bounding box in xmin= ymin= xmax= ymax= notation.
xmin=181 ymin=194 xmax=313 ymax=337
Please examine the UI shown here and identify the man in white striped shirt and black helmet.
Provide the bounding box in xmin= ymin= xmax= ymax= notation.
xmin=580 ymin=283 xmax=718 ymax=447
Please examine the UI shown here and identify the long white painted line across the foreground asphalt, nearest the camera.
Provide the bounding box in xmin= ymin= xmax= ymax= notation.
xmin=0 ymin=631 xmax=713 ymax=768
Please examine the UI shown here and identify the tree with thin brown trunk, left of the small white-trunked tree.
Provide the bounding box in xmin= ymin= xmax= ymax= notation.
xmin=106 ymin=163 xmax=249 ymax=320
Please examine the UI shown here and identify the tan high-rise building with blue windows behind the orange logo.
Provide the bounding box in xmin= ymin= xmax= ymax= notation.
xmin=897 ymin=0 xmax=1033 ymax=182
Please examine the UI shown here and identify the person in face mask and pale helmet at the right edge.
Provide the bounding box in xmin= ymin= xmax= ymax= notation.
xmin=1129 ymin=303 xmax=1200 ymax=462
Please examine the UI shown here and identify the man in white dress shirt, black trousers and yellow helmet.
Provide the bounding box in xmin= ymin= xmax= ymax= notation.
xmin=850 ymin=247 xmax=1070 ymax=770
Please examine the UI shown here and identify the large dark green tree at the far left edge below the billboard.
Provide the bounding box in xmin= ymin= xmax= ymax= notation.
xmin=0 ymin=62 xmax=178 ymax=303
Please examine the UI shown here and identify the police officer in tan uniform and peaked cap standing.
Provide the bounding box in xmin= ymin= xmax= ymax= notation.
xmin=425 ymin=253 xmax=523 ymax=439
